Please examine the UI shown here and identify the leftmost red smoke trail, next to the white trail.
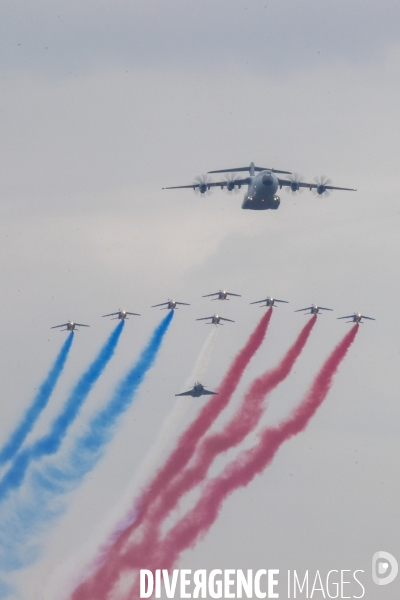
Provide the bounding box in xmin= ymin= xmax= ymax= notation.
xmin=71 ymin=308 xmax=272 ymax=600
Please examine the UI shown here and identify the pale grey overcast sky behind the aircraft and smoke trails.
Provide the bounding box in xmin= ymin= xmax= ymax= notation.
xmin=0 ymin=0 xmax=400 ymax=600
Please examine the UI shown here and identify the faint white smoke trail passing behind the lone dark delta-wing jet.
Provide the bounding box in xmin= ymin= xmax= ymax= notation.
xmin=41 ymin=327 xmax=219 ymax=600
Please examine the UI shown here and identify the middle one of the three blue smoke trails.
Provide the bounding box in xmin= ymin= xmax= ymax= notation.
xmin=0 ymin=321 xmax=124 ymax=502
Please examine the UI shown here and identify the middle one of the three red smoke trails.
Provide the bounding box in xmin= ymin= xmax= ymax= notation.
xmin=115 ymin=315 xmax=317 ymax=569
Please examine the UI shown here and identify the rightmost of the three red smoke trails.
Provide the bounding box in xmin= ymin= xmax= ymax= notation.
xmin=141 ymin=325 xmax=358 ymax=580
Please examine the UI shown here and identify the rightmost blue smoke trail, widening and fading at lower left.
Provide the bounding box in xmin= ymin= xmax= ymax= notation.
xmin=0 ymin=311 xmax=174 ymax=571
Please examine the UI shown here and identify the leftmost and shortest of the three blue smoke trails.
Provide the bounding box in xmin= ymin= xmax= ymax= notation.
xmin=0 ymin=331 xmax=74 ymax=465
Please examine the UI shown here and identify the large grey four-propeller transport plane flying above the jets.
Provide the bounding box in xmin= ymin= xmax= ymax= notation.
xmin=163 ymin=162 xmax=357 ymax=210
